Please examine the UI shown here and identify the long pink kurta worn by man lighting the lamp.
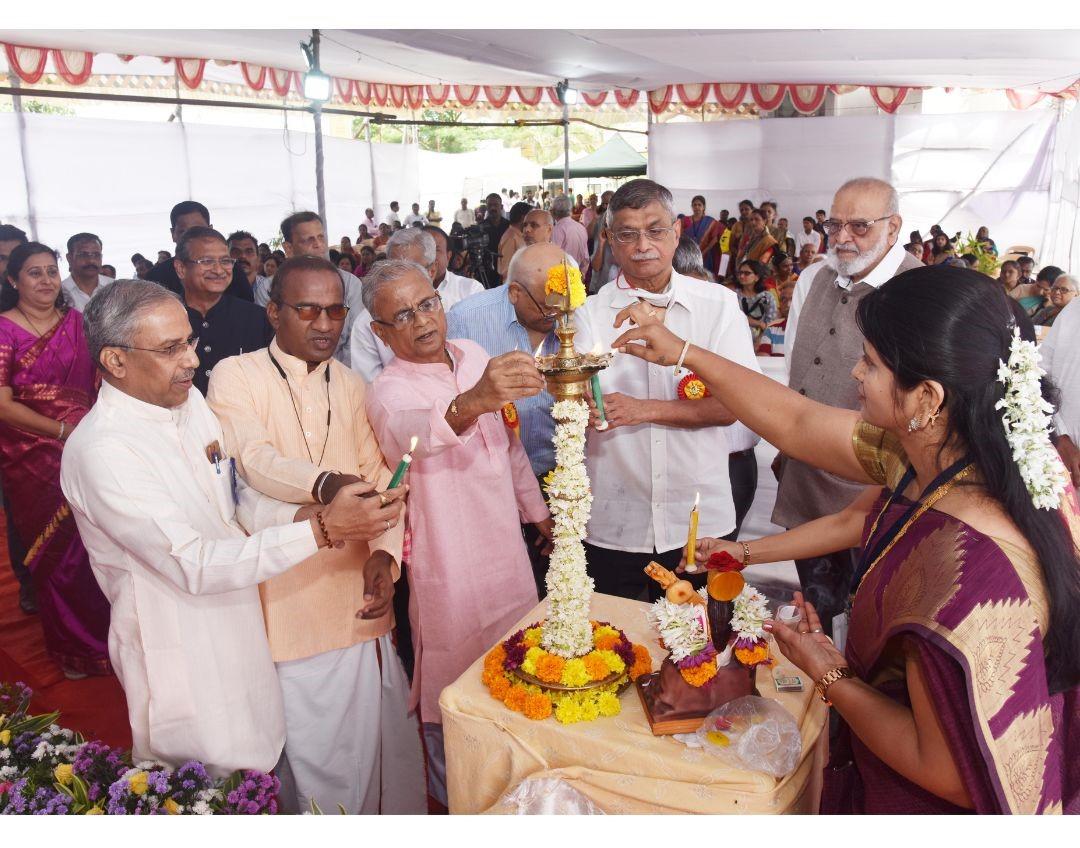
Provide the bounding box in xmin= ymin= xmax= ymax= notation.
xmin=367 ymin=339 xmax=549 ymax=724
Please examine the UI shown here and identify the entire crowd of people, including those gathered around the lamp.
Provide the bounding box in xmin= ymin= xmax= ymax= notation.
xmin=0 ymin=171 xmax=1080 ymax=812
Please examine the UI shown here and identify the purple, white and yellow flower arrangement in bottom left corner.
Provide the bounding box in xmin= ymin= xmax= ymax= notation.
xmin=0 ymin=683 xmax=281 ymax=816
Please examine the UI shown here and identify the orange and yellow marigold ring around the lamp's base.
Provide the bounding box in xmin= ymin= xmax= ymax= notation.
xmin=481 ymin=621 xmax=652 ymax=724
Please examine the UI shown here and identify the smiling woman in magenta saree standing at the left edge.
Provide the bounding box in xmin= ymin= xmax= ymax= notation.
xmin=0 ymin=242 xmax=110 ymax=677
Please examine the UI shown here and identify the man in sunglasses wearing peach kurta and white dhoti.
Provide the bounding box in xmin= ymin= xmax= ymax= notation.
xmin=207 ymin=257 xmax=427 ymax=813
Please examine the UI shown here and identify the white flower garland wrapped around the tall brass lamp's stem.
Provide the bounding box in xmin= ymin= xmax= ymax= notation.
xmin=540 ymin=401 xmax=594 ymax=659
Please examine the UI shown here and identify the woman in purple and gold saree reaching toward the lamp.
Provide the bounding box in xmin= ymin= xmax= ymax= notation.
xmin=616 ymin=266 xmax=1080 ymax=813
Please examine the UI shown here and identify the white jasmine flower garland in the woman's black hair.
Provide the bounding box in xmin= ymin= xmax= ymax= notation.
xmin=995 ymin=327 xmax=1066 ymax=510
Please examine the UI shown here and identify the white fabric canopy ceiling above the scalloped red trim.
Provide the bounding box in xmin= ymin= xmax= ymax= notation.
xmin=0 ymin=28 xmax=1080 ymax=92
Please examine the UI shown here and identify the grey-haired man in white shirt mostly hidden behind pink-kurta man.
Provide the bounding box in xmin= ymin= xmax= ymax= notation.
xmin=349 ymin=226 xmax=484 ymax=383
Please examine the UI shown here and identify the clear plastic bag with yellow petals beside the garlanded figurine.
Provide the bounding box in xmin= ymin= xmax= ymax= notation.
xmin=696 ymin=695 xmax=802 ymax=778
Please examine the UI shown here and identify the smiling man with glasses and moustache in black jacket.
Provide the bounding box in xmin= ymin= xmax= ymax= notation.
xmin=173 ymin=227 xmax=273 ymax=394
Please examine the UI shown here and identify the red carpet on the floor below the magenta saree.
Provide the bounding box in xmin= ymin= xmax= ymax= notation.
xmin=0 ymin=511 xmax=132 ymax=748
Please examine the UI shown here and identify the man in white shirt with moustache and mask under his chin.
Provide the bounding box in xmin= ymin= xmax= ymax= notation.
xmin=573 ymin=179 xmax=759 ymax=597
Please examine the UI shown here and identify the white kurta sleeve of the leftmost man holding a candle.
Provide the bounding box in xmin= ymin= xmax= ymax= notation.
xmin=63 ymin=440 xmax=319 ymax=595
